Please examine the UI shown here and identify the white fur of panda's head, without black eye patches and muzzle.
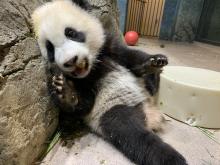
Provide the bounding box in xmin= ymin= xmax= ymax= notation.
xmin=32 ymin=0 xmax=105 ymax=72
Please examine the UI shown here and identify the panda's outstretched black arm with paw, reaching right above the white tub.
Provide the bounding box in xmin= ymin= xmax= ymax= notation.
xmin=104 ymin=33 xmax=168 ymax=77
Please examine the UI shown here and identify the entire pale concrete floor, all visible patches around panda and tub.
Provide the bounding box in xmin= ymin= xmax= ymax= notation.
xmin=41 ymin=38 xmax=220 ymax=165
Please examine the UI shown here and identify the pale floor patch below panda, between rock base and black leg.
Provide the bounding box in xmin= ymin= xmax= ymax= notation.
xmin=40 ymin=133 xmax=134 ymax=165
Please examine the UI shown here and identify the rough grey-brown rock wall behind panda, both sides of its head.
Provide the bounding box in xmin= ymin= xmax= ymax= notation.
xmin=0 ymin=0 xmax=119 ymax=165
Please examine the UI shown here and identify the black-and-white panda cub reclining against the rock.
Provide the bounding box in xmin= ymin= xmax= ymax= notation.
xmin=32 ymin=0 xmax=187 ymax=165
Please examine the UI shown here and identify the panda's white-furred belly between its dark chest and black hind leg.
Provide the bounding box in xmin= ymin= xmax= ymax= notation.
xmin=86 ymin=66 xmax=146 ymax=132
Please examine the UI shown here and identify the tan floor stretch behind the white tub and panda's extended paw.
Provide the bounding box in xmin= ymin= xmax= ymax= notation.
xmin=138 ymin=38 xmax=220 ymax=71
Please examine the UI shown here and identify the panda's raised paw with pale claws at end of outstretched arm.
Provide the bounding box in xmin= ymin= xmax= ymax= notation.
xmin=150 ymin=54 xmax=168 ymax=68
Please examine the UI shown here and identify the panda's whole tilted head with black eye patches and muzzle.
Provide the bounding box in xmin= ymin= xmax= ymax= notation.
xmin=32 ymin=0 xmax=105 ymax=78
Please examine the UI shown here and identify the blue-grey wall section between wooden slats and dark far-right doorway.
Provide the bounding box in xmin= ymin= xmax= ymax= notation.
xmin=160 ymin=0 xmax=204 ymax=42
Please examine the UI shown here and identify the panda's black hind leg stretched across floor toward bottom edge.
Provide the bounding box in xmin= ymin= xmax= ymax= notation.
xmin=100 ymin=105 xmax=187 ymax=165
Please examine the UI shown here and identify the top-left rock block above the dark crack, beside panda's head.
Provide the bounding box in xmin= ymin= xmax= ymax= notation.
xmin=0 ymin=0 xmax=43 ymax=48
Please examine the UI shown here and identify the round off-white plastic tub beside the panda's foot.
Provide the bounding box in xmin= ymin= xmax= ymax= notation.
xmin=158 ymin=66 xmax=220 ymax=128
